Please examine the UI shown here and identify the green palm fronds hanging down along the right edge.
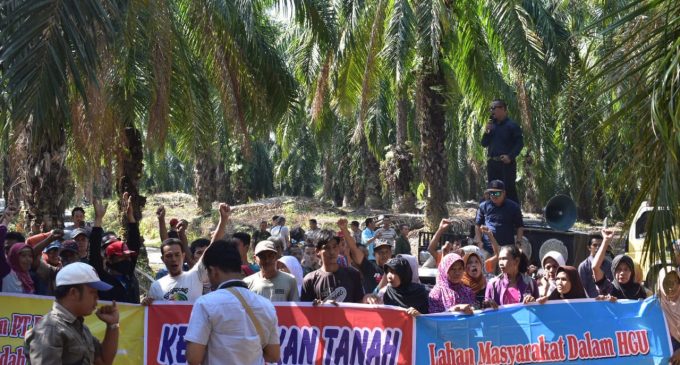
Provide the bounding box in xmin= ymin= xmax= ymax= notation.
xmin=588 ymin=0 xmax=680 ymax=274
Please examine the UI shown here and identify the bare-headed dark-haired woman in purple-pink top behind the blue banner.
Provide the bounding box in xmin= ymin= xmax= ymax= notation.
xmin=483 ymin=245 xmax=538 ymax=308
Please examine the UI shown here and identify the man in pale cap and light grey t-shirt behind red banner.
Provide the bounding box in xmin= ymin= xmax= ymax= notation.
xmin=243 ymin=237 xmax=300 ymax=302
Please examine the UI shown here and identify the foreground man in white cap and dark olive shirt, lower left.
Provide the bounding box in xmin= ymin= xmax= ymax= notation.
xmin=24 ymin=262 xmax=119 ymax=365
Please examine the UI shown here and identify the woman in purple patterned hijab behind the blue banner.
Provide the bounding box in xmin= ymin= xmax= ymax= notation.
xmin=428 ymin=253 xmax=475 ymax=314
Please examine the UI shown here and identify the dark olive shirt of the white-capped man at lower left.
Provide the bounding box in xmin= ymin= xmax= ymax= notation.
xmin=24 ymin=302 xmax=102 ymax=365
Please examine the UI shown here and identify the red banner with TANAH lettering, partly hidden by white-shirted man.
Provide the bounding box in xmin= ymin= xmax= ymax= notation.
xmin=145 ymin=303 xmax=413 ymax=365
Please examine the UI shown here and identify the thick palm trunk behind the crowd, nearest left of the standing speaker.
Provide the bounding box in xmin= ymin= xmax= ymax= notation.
xmin=416 ymin=68 xmax=449 ymax=230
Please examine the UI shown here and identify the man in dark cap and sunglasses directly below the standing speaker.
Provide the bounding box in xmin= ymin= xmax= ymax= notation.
xmin=475 ymin=180 xmax=524 ymax=253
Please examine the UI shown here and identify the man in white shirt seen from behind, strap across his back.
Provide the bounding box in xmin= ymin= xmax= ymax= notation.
xmin=184 ymin=228 xmax=281 ymax=365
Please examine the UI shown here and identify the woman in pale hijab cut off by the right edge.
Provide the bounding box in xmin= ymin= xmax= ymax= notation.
xmin=658 ymin=270 xmax=680 ymax=364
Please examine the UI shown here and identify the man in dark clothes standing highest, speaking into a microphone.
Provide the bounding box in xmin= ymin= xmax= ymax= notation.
xmin=482 ymin=99 xmax=524 ymax=203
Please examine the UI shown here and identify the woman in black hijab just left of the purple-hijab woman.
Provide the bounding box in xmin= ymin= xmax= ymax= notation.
xmin=383 ymin=257 xmax=428 ymax=315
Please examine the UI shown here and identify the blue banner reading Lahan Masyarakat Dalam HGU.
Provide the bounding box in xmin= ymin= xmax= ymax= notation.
xmin=415 ymin=298 xmax=671 ymax=365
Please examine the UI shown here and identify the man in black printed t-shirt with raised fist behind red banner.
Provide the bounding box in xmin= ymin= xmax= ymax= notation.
xmin=300 ymin=229 xmax=364 ymax=303
